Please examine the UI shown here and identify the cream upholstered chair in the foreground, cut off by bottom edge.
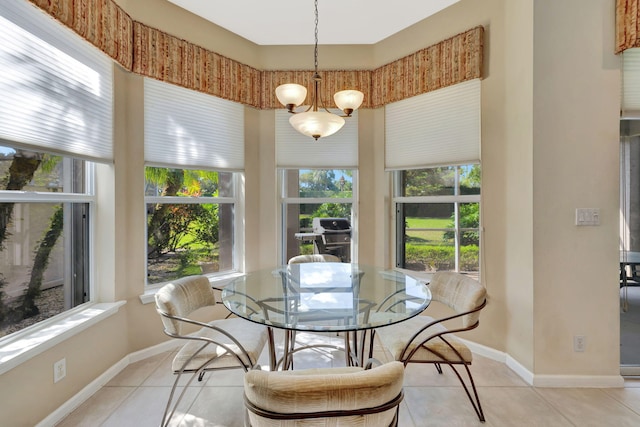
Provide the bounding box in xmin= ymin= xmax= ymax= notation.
xmin=244 ymin=362 xmax=404 ymax=427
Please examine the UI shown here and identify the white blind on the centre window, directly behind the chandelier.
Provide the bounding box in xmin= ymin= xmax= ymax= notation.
xmin=276 ymin=109 xmax=358 ymax=169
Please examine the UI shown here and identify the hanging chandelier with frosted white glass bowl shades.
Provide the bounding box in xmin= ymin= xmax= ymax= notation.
xmin=276 ymin=0 xmax=364 ymax=141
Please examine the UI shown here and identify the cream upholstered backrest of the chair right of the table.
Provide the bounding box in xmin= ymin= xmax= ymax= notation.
xmin=429 ymin=271 xmax=487 ymax=328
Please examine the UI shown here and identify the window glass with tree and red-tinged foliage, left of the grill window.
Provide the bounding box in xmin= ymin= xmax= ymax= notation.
xmin=145 ymin=166 xmax=237 ymax=284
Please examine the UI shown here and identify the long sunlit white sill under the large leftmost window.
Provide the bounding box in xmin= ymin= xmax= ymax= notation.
xmin=0 ymin=301 xmax=126 ymax=375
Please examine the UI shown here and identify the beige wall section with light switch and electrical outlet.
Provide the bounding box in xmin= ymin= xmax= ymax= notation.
xmin=533 ymin=0 xmax=620 ymax=375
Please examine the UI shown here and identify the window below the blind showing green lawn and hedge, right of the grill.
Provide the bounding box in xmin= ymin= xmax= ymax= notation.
xmin=394 ymin=164 xmax=480 ymax=274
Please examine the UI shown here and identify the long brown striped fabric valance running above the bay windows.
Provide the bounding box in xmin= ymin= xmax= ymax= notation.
xmin=30 ymin=0 xmax=482 ymax=109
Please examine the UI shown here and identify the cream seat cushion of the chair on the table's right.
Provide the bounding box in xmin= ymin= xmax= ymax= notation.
xmin=376 ymin=316 xmax=473 ymax=363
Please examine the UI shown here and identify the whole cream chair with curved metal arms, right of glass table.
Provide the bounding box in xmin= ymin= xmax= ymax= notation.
xmin=374 ymin=272 xmax=486 ymax=422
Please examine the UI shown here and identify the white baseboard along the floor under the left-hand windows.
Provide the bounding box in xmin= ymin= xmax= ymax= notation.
xmin=36 ymin=340 xmax=180 ymax=427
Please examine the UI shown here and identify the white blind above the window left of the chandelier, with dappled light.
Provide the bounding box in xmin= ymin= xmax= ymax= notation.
xmin=144 ymin=78 xmax=244 ymax=171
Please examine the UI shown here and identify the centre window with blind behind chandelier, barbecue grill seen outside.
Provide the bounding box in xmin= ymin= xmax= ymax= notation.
xmin=275 ymin=106 xmax=358 ymax=263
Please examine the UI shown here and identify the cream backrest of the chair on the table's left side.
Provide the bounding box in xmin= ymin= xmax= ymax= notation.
xmin=155 ymin=275 xmax=216 ymax=335
